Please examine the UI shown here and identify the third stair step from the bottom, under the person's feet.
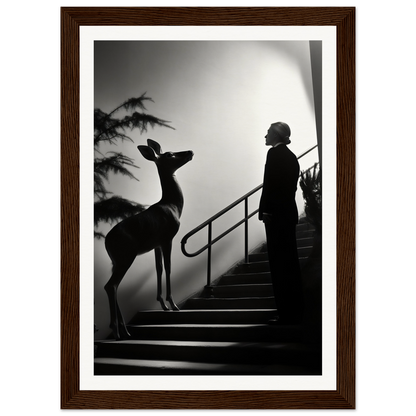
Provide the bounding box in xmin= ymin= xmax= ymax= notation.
xmin=128 ymin=324 xmax=302 ymax=342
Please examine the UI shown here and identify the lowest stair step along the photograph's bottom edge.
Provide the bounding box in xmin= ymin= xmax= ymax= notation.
xmin=94 ymin=358 xmax=321 ymax=375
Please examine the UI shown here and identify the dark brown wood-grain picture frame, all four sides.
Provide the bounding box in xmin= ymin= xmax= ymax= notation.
xmin=60 ymin=4 xmax=356 ymax=410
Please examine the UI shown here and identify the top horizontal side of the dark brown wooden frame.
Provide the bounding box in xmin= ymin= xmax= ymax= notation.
xmin=61 ymin=4 xmax=355 ymax=26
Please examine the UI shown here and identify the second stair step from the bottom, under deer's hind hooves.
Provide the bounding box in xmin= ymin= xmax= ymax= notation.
xmin=95 ymin=340 xmax=321 ymax=368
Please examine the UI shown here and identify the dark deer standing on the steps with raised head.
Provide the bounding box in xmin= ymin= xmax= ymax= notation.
xmin=104 ymin=139 xmax=194 ymax=340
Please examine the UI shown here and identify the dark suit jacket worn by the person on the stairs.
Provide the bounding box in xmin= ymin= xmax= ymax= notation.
xmin=259 ymin=144 xmax=299 ymax=224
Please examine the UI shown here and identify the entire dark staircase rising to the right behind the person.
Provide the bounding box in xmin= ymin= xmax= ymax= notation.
xmin=94 ymin=224 xmax=321 ymax=375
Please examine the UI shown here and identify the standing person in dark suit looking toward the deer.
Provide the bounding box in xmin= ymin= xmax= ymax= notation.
xmin=259 ymin=122 xmax=303 ymax=325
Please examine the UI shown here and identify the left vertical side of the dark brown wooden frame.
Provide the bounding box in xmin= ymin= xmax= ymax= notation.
xmin=60 ymin=6 xmax=79 ymax=407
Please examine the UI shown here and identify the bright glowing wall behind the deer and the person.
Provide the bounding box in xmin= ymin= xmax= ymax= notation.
xmin=94 ymin=41 xmax=318 ymax=338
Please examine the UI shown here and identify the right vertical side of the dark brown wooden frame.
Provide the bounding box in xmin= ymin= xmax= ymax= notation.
xmin=337 ymin=5 xmax=356 ymax=410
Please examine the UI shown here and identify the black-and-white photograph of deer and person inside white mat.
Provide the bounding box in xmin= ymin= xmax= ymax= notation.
xmin=81 ymin=26 xmax=334 ymax=394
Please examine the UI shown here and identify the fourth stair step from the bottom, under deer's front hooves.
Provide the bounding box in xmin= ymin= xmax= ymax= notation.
xmin=130 ymin=309 xmax=276 ymax=325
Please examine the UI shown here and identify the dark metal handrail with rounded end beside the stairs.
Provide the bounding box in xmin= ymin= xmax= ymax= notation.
xmin=181 ymin=145 xmax=318 ymax=286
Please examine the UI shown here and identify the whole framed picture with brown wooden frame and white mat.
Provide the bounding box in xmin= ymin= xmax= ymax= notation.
xmin=56 ymin=3 xmax=361 ymax=414
